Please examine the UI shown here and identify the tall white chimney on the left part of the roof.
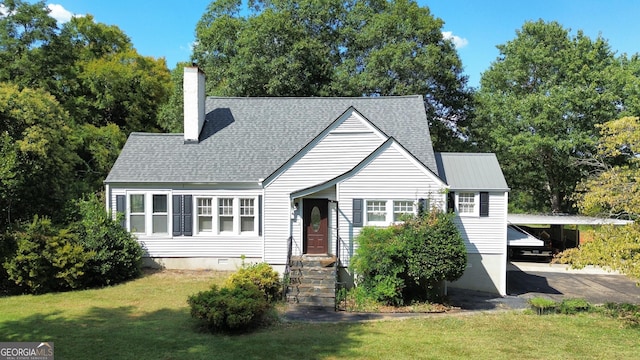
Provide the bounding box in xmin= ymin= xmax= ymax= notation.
xmin=182 ymin=66 xmax=206 ymax=144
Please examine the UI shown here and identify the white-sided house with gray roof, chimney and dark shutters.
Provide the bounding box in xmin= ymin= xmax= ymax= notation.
xmin=105 ymin=67 xmax=509 ymax=295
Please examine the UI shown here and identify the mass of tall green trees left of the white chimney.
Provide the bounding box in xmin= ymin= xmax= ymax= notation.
xmin=0 ymin=0 xmax=171 ymax=230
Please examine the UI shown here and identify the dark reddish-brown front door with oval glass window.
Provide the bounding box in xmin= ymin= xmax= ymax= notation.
xmin=302 ymin=199 xmax=329 ymax=254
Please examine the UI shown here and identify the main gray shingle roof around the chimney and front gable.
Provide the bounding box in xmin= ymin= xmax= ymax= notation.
xmin=105 ymin=95 xmax=437 ymax=183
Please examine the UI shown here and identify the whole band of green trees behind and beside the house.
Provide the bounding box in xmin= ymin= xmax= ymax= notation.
xmin=0 ymin=0 xmax=640 ymax=278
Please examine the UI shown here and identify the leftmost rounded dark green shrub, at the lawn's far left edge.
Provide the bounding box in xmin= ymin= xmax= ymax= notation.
xmin=4 ymin=216 xmax=95 ymax=293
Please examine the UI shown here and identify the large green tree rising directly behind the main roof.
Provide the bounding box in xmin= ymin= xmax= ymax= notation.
xmin=192 ymin=0 xmax=471 ymax=150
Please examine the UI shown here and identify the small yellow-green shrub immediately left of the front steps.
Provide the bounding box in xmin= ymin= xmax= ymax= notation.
xmin=224 ymin=263 xmax=282 ymax=302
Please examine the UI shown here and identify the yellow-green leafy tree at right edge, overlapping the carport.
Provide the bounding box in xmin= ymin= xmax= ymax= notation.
xmin=557 ymin=117 xmax=640 ymax=280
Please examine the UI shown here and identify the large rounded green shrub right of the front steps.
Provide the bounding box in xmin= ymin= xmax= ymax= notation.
xmin=352 ymin=211 xmax=467 ymax=305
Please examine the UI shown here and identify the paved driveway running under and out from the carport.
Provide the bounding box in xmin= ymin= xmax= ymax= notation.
xmin=507 ymin=262 xmax=640 ymax=304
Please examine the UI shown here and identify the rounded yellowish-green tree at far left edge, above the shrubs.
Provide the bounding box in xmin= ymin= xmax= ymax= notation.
xmin=0 ymin=83 xmax=79 ymax=227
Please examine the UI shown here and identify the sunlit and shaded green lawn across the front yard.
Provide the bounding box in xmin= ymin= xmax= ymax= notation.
xmin=0 ymin=272 xmax=640 ymax=360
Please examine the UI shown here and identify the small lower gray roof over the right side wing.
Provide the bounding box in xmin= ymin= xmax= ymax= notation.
xmin=435 ymin=153 xmax=509 ymax=191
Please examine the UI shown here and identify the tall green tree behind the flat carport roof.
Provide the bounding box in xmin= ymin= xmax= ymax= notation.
xmin=472 ymin=20 xmax=640 ymax=212
